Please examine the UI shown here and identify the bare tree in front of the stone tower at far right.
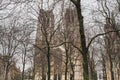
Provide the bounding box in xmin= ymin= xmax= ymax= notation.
xmin=95 ymin=0 xmax=120 ymax=80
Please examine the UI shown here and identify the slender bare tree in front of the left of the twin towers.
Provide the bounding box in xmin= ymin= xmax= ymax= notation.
xmin=36 ymin=9 xmax=56 ymax=80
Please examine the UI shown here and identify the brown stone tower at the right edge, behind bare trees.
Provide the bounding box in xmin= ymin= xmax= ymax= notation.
xmin=105 ymin=18 xmax=120 ymax=80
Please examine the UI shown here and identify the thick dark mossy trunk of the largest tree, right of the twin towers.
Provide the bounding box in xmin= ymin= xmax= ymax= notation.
xmin=71 ymin=0 xmax=89 ymax=80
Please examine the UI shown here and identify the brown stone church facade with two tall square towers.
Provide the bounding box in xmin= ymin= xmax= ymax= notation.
xmin=34 ymin=9 xmax=83 ymax=80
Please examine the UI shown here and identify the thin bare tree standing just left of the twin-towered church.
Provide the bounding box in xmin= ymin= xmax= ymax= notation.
xmin=20 ymin=28 xmax=33 ymax=80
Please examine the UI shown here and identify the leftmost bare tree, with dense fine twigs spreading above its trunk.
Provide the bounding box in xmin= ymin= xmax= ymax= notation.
xmin=1 ymin=19 xmax=19 ymax=80
